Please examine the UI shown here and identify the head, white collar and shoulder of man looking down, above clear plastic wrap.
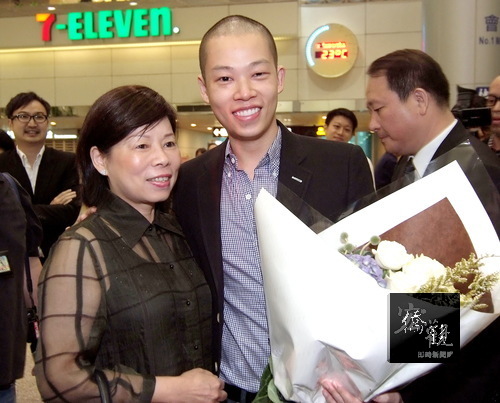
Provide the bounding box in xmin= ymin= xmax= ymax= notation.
xmin=366 ymin=49 xmax=500 ymax=190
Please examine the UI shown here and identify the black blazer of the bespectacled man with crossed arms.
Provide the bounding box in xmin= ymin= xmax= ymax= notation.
xmin=0 ymin=147 xmax=80 ymax=257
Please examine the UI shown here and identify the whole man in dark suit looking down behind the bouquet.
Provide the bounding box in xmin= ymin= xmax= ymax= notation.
xmin=328 ymin=49 xmax=500 ymax=403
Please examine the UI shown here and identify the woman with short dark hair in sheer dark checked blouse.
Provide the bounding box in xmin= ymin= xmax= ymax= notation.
xmin=35 ymin=86 xmax=226 ymax=402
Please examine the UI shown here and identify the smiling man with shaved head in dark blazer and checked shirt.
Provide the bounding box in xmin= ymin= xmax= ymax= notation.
xmin=174 ymin=16 xmax=373 ymax=402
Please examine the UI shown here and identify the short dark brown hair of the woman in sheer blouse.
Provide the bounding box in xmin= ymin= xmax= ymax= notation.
xmin=76 ymin=85 xmax=176 ymax=206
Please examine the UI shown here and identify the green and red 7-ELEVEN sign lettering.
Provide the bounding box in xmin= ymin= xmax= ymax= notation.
xmin=36 ymin=7 xmax=172 ymax=42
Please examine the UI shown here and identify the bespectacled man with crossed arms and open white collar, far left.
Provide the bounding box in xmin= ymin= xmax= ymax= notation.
xmin=0 ymin=92 xmax=80 ymax=258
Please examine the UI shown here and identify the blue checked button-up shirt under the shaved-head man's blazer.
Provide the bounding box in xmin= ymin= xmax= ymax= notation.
xmin=220 ymin=131 xmax=281 ymax=392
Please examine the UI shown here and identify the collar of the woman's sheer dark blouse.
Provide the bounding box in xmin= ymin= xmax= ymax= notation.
xmin=96 ymin=192 xmax=184 ymax=248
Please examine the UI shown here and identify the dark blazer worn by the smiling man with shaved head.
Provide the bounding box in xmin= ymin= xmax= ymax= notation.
xmin=174 ymin=122 xmax=374 ymax=370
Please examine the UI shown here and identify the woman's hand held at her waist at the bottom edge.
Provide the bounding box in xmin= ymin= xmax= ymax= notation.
xmin=153 ymin=368 xmax=227 ymax=403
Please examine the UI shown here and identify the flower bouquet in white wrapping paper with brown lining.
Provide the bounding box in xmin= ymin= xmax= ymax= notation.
xmin=255 ymin=163 xmax=500 ymax=402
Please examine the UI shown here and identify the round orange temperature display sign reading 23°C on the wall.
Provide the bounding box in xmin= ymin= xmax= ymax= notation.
xmin=306 ymin=24 xmax=358 ymax=77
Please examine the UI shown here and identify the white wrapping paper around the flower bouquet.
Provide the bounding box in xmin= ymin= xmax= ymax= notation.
xmin=255 ymin=163 xmax=500 ymax=403
